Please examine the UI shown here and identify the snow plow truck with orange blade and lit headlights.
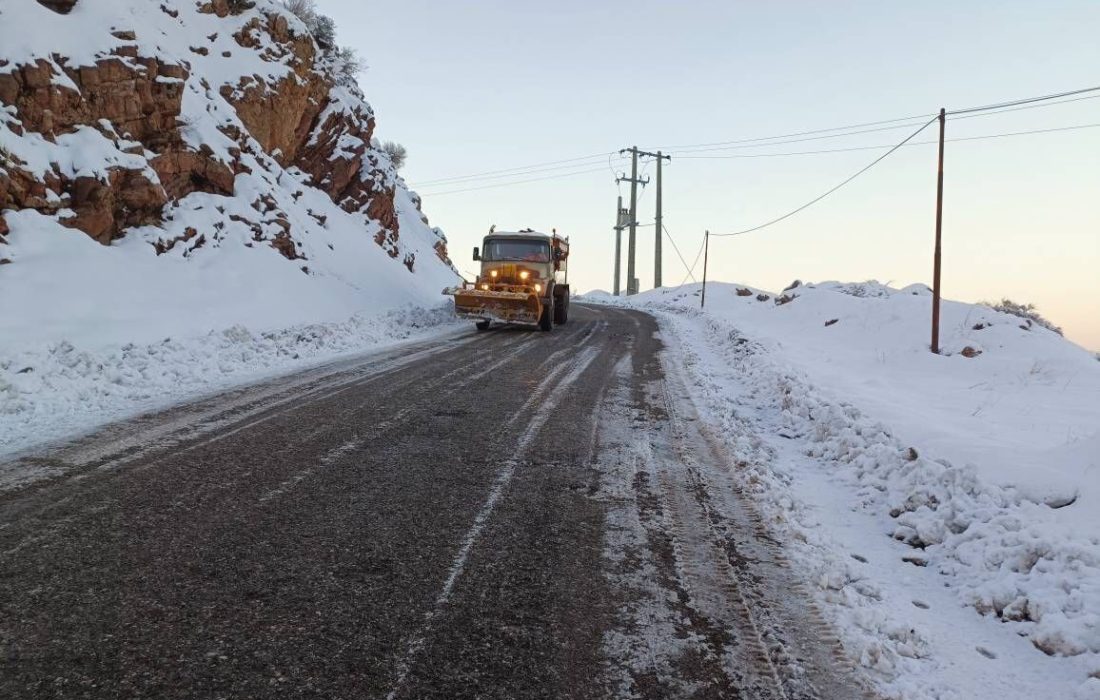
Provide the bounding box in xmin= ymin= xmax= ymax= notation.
xmin=443 ymin=229 xmax=569 ymax=330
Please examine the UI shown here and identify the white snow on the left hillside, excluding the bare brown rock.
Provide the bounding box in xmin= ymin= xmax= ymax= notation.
xmin=0 ymin=0 xmax=458 ymax=453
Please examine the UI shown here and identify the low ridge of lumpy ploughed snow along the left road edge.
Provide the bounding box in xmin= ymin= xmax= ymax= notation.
xmin=0 ymin=304 xmax=463 ymax=455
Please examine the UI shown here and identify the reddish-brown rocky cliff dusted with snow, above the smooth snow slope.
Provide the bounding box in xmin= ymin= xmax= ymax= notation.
xmin=0 ymin=0 xmax=452 ymax=278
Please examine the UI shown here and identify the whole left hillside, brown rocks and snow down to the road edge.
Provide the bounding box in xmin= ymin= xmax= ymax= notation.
xmin=0 ymin=0 xmax=457 ymax=451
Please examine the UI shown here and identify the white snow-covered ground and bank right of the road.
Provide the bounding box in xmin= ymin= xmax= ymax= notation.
xmin=585 ymin=283 xmax=1100 ymax=700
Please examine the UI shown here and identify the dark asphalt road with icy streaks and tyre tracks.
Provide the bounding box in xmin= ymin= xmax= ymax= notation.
xmin=0 ymin=305 xmax=862 ymax=700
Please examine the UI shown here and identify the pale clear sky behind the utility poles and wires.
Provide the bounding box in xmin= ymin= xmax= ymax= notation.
xmin=319 ymin=0 xmax=1100 ymax=350
